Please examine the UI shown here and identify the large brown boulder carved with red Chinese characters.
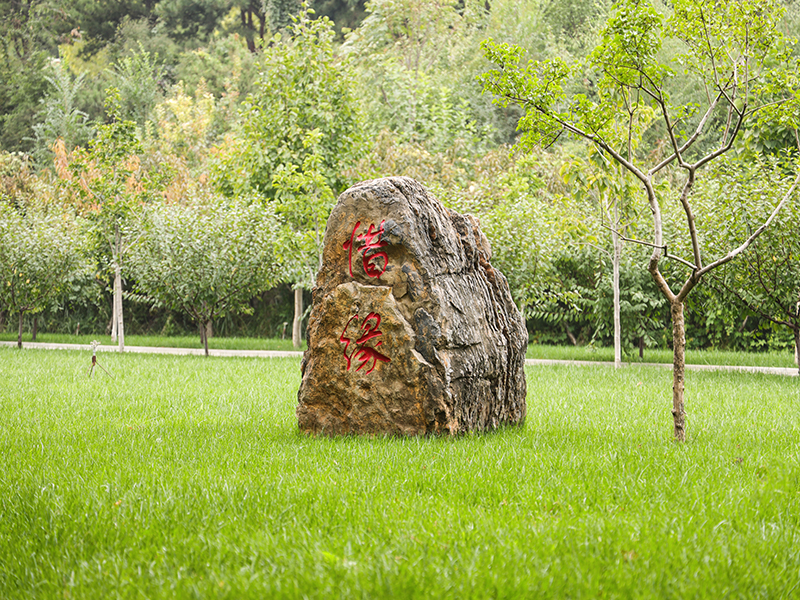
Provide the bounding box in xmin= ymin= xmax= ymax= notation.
xmin=297 ymin=177 xmax=528 ymax=435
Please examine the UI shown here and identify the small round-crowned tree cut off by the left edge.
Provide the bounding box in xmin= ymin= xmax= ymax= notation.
xmin=0 ymin=202 xmax=87 ymax=348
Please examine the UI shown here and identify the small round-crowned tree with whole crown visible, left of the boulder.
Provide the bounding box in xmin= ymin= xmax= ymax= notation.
xmin=126 ymin=193 xmax=282 ymax=356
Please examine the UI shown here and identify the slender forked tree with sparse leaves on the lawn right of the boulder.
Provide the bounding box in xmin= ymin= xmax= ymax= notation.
xmin=481 ymin=0 xmax=800 ymax=441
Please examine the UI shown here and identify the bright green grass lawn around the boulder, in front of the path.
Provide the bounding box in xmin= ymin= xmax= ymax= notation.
xmin=0 ymin=348 xmax=800 ymax=599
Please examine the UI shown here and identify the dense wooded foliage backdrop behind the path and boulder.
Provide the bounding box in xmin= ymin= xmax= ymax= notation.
xmin=0 ymin=0 xmax=800 ymax=366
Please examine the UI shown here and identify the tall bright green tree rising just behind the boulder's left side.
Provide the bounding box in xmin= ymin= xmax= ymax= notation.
xmin=211 ymin=4 xmax=362 ymax=345
